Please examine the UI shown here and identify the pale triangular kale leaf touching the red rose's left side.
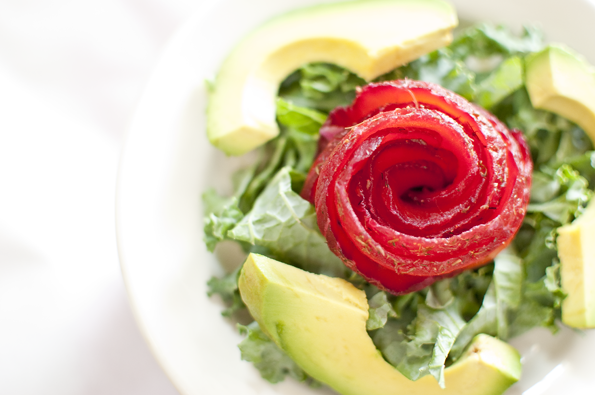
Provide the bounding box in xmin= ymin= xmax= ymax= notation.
xmin=228 ymin=167 xmax=348 ymax=278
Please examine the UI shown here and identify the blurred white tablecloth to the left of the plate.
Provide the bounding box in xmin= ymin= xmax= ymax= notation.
xmin=0 ymin=0 xmax=200 ymax=395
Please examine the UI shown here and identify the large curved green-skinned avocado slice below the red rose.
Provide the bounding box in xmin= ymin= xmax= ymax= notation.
xmin=239 ymin=254 xmax=521 ymax=395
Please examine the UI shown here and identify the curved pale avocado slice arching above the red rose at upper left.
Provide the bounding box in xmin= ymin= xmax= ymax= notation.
xmin=207 ymin=0 xmax=458 ymax=155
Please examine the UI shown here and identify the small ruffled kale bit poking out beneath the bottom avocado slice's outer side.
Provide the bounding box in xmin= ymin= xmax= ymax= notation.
xmin=238 ymin=321 xmax=308 ymax=383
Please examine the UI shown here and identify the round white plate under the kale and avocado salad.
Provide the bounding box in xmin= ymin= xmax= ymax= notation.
xmin=117 ymin=0 xmax=595 ymax=395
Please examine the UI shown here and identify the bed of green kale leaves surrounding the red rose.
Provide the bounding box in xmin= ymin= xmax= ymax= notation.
xmin=203 ymin=1 xmax=595 ymax=394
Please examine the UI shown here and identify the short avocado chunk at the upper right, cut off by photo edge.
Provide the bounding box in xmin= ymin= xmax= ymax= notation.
xmin=525 ymin=44 xmax=595 ymax=141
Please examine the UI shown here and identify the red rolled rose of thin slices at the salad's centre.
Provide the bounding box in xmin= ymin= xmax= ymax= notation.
xmin=302 ymin=80 xmax=532 ymax=294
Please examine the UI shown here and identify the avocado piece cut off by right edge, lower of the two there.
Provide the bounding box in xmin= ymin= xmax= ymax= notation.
xmin=557 ymin=202 xmax=595 ymax=328
